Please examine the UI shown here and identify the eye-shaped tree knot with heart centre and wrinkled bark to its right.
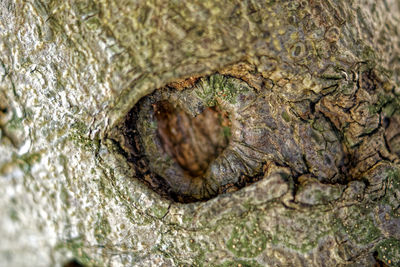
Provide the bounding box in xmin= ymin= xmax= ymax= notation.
xmin=112 ymin=74 xmax=348 ymax=202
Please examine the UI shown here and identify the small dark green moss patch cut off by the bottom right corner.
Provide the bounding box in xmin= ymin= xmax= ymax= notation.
xmin=376 ymin=238 xmax=400 ymax=266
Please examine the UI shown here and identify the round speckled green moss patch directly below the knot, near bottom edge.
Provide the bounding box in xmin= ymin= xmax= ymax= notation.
xmin=226 ymin=223 xmax=267 ymax=258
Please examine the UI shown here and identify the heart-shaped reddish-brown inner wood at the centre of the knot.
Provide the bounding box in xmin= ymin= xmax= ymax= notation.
xmin=153 ymin=101 xmax=230 ymax=177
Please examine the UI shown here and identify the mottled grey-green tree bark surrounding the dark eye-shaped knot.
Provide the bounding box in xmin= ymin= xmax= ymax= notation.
xmin=0 ymin=0 xmax=400 ymax=266
